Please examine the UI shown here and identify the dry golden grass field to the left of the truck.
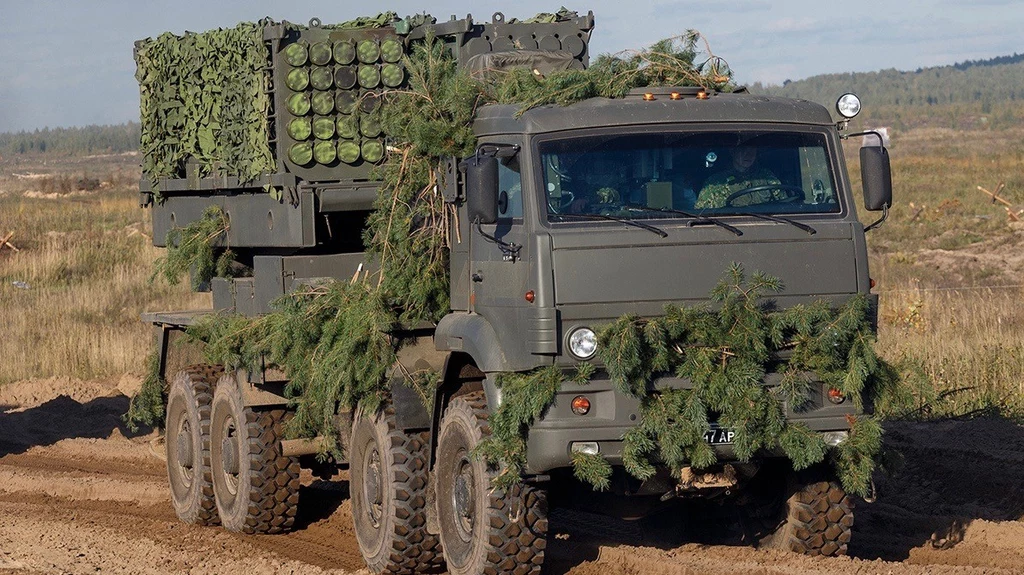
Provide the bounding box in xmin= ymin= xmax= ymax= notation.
xmin=0 ymin=156 xmax=208 ymax=384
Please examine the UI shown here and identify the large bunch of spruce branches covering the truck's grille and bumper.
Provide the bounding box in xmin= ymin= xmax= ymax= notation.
xmin=565 ymin=264 xmax=900 ymax=494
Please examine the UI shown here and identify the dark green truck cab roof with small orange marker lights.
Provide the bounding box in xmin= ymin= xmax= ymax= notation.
xmin=474 ymin=88 xmax=836 ymax=136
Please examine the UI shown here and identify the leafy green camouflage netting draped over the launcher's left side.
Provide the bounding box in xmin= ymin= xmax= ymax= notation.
xmin=135 ymin=20 xmax=274 ymax=181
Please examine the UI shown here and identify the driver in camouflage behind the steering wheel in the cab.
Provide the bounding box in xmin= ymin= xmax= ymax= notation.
xmin=693 ymin=144 xmax=782 ymax=210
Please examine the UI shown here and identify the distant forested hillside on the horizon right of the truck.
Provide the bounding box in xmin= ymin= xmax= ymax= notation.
xmin=750 ymin=54 xmax=1024 ymax=114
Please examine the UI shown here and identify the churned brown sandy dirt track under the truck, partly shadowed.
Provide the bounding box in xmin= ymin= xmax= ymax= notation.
xmin=0 ymin=378 xmax=1024 ymax=575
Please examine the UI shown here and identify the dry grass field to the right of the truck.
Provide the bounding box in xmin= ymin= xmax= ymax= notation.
xmin=847 ymin=128 xmax=1024 ymax=417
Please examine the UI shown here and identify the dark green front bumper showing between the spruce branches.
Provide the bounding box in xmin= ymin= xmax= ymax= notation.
xmin=526 ymin=373 xmax=858 ymax=475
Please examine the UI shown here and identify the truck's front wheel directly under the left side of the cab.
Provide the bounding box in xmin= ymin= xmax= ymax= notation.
xmin=434 ymin=392 xmax=548 ymax=575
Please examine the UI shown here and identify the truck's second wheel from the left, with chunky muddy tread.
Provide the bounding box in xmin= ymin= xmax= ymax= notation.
xmin=210 ymin=373 xmax=299 ymax=533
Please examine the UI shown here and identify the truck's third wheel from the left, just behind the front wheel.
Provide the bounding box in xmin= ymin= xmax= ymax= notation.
xmin=349 ymin=405 xmax=444 ymax=575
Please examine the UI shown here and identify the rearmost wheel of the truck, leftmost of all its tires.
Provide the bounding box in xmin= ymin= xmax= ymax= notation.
xmin=165 ymin=365 xmax=224 ymax=525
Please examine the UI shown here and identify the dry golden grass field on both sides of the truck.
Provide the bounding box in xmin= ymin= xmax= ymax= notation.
xmin=0 ymin=127 xmax=1024 ymax=416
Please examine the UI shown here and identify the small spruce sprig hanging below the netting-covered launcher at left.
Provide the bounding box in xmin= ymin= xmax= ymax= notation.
xmin=154 ymin=206 xmax=234 ymax=290
